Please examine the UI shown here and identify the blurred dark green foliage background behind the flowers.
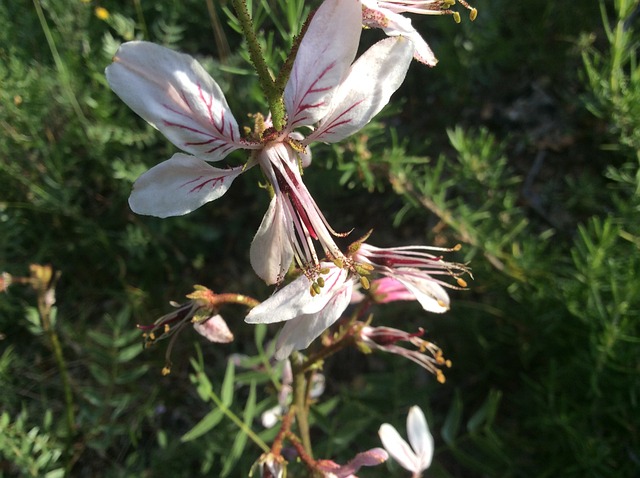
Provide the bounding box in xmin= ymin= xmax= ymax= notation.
xmin=0 ymin=0 xmax=640 ymax=478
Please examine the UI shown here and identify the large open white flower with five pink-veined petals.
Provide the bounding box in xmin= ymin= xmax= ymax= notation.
xmin=106 ymin=0 xmax=413 ymax=284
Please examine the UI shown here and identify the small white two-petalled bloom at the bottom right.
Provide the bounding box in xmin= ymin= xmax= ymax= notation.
xmin=378 ymin=406 xmax=433 ymax=478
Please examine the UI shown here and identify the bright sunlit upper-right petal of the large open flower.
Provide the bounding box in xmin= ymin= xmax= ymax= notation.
xmin=305 ymin=37 xmax=413 ymax=144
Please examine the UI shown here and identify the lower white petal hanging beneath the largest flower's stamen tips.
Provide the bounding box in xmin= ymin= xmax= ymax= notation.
xmin=275 ymin=281 xmax=353 ymax=360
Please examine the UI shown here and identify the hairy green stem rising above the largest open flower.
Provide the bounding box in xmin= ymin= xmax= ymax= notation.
xmin=232 ymin=0 xmax=286 ymax=131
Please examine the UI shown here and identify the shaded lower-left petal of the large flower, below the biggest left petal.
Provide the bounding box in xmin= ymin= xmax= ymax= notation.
xmin=129 ymin=153 xmax=242 ymax=217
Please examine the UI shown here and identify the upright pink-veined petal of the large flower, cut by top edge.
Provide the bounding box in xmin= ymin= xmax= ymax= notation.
xmin=284 ymin=0 xmax=362 ymax=129
